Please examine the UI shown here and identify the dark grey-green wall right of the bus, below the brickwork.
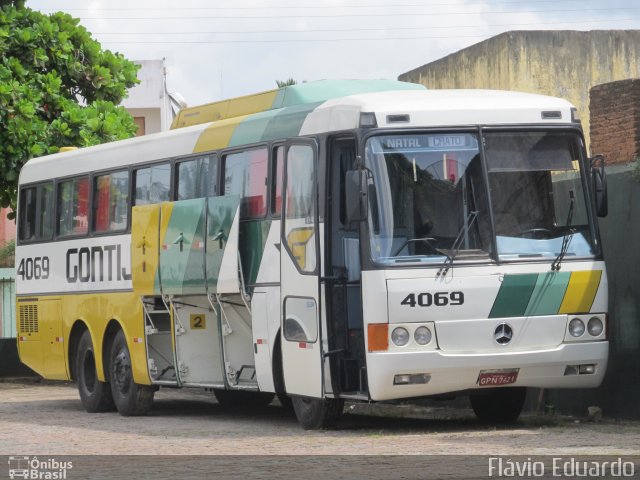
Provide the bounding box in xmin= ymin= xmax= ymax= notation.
xmin=548 ymin=165 xmax=640 ymax=418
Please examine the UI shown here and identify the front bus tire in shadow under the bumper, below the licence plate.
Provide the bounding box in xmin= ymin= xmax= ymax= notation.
xmin=469 ymin=387 xmax=527 ymax=424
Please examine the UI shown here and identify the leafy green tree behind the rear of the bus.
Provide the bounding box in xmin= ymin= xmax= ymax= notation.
xmin=0 ymin=0 xmax=138 ymax=218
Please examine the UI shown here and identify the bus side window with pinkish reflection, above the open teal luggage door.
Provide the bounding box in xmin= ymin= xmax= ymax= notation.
xmin=224 ymin=148 xmax=269 ymax=218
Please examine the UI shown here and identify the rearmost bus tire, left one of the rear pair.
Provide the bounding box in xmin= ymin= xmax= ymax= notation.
xmin=75 ymin=330 xmax=114 ymax=413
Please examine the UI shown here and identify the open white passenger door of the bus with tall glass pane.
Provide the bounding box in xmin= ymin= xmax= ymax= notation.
xmin=280 ymin=140 xmax=323 ymax=398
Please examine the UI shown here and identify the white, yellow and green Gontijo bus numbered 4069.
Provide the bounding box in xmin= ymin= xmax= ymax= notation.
xmin=16 ymin=81 xmax=608 ymax=428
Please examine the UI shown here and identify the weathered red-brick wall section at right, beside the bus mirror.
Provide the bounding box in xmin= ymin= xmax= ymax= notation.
xmin=589 ymin=79 xmax=640 ymax=164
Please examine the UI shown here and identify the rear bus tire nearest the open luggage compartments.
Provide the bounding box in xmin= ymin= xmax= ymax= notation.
xmin=109 ymin=330 xmax=155 ymax=417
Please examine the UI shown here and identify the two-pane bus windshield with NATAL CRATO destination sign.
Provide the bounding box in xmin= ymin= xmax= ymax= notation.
xmin=365 ymin=131 xmax=595 ymax=264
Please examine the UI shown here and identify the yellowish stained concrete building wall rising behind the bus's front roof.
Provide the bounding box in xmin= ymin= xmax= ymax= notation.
xmin=398 ymin=30 xmax=640 ymax=146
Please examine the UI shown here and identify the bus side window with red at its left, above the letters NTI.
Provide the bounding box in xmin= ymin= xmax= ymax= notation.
xmin=93 ymin=171 xmax=129 ymax=232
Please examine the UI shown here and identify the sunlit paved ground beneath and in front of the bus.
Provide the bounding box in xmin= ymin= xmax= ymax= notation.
xmin=0 ymin=383 xmax=640 ymax=478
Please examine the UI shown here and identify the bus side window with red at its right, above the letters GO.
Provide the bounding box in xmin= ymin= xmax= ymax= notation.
xmin=58 ymin=177 xmax=89 ymax=237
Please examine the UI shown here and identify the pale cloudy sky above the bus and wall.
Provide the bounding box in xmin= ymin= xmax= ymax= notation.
xmin=27 ymin=0 xmax=640 ymax=105
